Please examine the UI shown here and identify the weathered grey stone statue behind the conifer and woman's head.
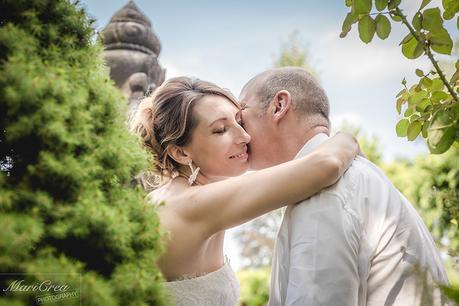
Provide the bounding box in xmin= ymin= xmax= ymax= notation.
xmin=102 ymin=0 xmax=166 ymax=120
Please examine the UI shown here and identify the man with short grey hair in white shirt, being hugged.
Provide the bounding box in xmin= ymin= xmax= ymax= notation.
xmin=240 ymin=67 xmax=448 ymax=306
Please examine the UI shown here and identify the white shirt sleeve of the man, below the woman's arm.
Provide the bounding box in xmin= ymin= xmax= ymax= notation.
xmin=286 ymin=192 xmax=360 ymax=306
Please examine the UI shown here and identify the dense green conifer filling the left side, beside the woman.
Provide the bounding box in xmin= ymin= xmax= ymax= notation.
xmin=0 ymin=0 xmax=169 ymax=305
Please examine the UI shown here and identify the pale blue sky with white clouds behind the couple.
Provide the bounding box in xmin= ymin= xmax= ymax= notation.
xmin=81 ymin=0 xmax=457 ymax=266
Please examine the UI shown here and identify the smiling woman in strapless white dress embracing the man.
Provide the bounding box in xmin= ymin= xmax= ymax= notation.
xmin=131 ymin=77 xmax=359 ymax=306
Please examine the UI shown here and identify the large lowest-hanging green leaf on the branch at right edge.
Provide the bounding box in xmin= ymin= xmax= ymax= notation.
xmin=427 ymin=109 xmax=456 ymax=154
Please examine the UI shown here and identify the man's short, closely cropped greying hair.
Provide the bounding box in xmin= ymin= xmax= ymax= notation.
xmin=242 ymin=67 xmax=330 ymax=125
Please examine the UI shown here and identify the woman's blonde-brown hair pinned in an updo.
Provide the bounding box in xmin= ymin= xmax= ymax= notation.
xmin=131 ymin=77 xmax=240 ymax=181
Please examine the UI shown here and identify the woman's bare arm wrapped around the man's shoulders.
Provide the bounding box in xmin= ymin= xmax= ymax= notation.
xmin=176 ymin=133 xmax=359 ymax=236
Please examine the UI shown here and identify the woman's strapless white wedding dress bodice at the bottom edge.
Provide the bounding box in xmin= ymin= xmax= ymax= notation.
xmin=164 ymin=259 xmax=239 ymax=306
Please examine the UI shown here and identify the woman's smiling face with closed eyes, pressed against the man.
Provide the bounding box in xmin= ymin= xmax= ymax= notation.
xmin=184 ymin=95 xmax=250 ymax=181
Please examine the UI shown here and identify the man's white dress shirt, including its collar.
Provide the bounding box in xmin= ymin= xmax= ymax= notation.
xmin=269 ymin=134 xmax=448 ymax=306
